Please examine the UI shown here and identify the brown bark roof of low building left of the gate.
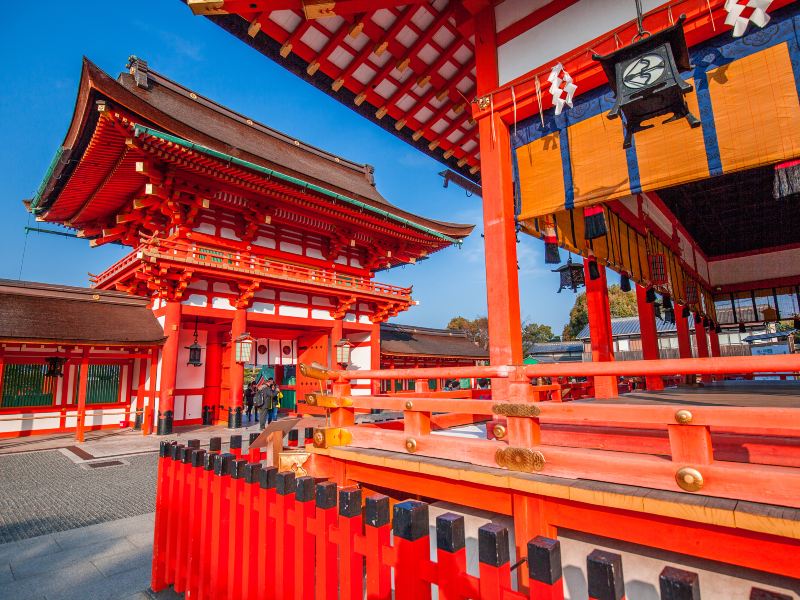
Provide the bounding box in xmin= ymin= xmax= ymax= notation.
xmin=0 ymin=279 xmax=164 ymax=346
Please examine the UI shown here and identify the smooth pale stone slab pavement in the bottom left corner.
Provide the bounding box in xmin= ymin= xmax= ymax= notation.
xmin=0 ymin=513 xmax=161 ymax=600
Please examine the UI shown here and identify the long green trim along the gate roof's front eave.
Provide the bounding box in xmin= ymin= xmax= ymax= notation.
xmin=130 ymin=125 xmax=461 ymax=245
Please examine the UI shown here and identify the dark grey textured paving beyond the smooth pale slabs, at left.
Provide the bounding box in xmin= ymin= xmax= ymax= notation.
xmin=0 ymin=450 xmax=158 ymax=544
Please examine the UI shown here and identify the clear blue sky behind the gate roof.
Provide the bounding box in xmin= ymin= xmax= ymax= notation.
xmin=0 ymin=0 xmax=574 ymax=333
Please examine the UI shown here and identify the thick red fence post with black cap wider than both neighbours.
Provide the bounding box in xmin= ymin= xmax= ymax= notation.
xmin=392 ymin=500 xmax=431 ymax=600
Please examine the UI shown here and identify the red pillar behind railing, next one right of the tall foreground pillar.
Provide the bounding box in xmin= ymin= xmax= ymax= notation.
xmin=583 ymin=259 xmax=619 ymax=398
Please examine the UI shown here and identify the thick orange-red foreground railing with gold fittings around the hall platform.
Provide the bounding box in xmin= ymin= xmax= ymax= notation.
xmin=301 ymin=355 xmax=800 ymax=508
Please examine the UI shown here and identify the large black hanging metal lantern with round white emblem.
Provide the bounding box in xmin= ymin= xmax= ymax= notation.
xmin=593 ymin=13 xmax=701 ymax=148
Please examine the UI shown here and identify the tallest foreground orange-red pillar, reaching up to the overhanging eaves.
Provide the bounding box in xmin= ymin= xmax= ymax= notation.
xmin=475 ymin=7 xmax=522 ymax=399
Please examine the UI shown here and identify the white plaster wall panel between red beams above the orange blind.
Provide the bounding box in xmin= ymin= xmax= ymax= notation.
xmin=497 ymin=0 xmax=666 ymax=85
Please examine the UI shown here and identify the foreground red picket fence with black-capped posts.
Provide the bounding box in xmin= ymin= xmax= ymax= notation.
xmin=151 ymin=436 xmax=789 ymax=600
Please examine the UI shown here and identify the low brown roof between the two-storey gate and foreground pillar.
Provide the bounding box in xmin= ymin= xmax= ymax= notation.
xmin=381 ymin=323 xmax=489 ymax=360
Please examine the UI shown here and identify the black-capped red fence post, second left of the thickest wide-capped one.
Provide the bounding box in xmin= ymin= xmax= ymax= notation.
xmin=339 ymin=487 xmax=364 ymax=600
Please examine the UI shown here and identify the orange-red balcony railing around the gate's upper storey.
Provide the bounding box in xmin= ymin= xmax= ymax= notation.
xmin=92 ymin=240 xmax=412 ymax=302
